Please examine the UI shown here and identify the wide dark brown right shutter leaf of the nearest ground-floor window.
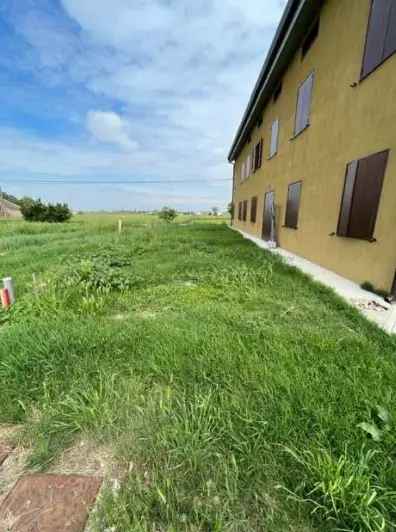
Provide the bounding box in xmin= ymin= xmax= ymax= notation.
xmin=348 ymin=151 xmax=389 ymax=239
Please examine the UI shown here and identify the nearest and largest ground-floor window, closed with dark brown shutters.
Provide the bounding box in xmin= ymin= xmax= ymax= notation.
xmin=337 ymin=150 xmax=389 ymax=240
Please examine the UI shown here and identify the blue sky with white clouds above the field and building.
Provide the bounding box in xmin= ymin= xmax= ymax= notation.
xmin=0 ymin=0 xmax=286 ymax=210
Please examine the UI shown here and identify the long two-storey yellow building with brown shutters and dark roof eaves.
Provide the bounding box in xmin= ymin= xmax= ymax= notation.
xmin=229 ymin=0 xmax=396 ymax=293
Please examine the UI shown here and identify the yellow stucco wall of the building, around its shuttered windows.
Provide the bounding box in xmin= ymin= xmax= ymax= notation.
xmin=234 ymin=0 xmax=396 ymax=290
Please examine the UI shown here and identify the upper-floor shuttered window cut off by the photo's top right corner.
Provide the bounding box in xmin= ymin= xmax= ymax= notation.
xmin=361 ymin=0 xmax=396 ymax=78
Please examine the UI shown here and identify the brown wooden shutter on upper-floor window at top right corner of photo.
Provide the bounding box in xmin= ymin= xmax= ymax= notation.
xmin=362 ymin=0 xmax=394 ymax=77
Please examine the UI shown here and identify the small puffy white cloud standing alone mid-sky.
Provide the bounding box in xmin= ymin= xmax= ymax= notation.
xmin=86 ymin=111 xmax=138 ymax=150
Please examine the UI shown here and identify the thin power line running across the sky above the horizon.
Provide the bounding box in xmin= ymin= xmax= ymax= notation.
xmin=0 ymin=178 xmax=232 ymax=185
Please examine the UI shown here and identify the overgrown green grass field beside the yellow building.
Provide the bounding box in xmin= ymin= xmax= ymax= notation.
xmin=0 ymin=215 xmax=396 ymax=532
